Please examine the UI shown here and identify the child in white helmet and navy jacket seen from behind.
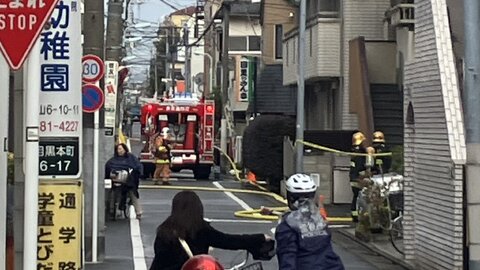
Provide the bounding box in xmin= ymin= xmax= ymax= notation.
xmin=275 ymin=174 xmax=344 ymax=270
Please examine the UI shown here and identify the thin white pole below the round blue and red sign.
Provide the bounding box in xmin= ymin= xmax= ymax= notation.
xmin=92 ymin=82 xmax=100 ymax=263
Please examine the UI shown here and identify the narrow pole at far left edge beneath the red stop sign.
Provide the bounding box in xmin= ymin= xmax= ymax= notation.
xmin=0 ymin=52 xmax=10 ymax=268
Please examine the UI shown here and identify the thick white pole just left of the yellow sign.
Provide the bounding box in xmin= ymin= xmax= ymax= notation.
xmin=23 ymin=40 xmax=40 ymax=269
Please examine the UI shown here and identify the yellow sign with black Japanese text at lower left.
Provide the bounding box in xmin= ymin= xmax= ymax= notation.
xmin=37 ymin=180 xmax=83 ymax=270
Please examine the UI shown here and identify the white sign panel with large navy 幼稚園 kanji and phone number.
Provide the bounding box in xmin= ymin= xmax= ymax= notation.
xmin=38 ymin=0 xmax=83 ymax=141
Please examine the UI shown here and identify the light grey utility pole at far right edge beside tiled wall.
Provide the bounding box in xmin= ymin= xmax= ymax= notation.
xmin=463 ymin=0 xmax=480 ymax=270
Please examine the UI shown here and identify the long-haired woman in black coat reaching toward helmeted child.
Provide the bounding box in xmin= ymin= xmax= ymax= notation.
xmin=150 ymin=191 xmax=274 ymax=270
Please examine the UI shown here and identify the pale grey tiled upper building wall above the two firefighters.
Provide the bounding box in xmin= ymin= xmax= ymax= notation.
xmin=341 ymin=0 xmax=390 ymax=129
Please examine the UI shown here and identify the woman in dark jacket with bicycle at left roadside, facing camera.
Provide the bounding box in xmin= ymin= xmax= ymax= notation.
xmin=105 ymin=143 xmax=143 ymax=219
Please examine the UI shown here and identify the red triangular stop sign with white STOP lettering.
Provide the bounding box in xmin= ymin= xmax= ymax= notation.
xmin=0 ymin=0 xmax=58 ymax=70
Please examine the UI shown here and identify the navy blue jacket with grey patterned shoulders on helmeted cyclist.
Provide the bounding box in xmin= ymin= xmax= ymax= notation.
xmin=275 ymin=201 xmax=344 ymax=270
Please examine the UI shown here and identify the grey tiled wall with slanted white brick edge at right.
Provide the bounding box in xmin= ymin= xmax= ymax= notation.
xmin=404 ymin=0 xmax=466 ymax=269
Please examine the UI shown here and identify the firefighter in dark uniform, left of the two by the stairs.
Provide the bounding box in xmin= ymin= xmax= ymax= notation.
xmin=350 ymin=132 xmax=366 ymax=222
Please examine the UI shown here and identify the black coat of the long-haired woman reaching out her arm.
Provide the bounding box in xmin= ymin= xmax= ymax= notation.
xmin=150 ymin=221 xmax=265 ymax=270
